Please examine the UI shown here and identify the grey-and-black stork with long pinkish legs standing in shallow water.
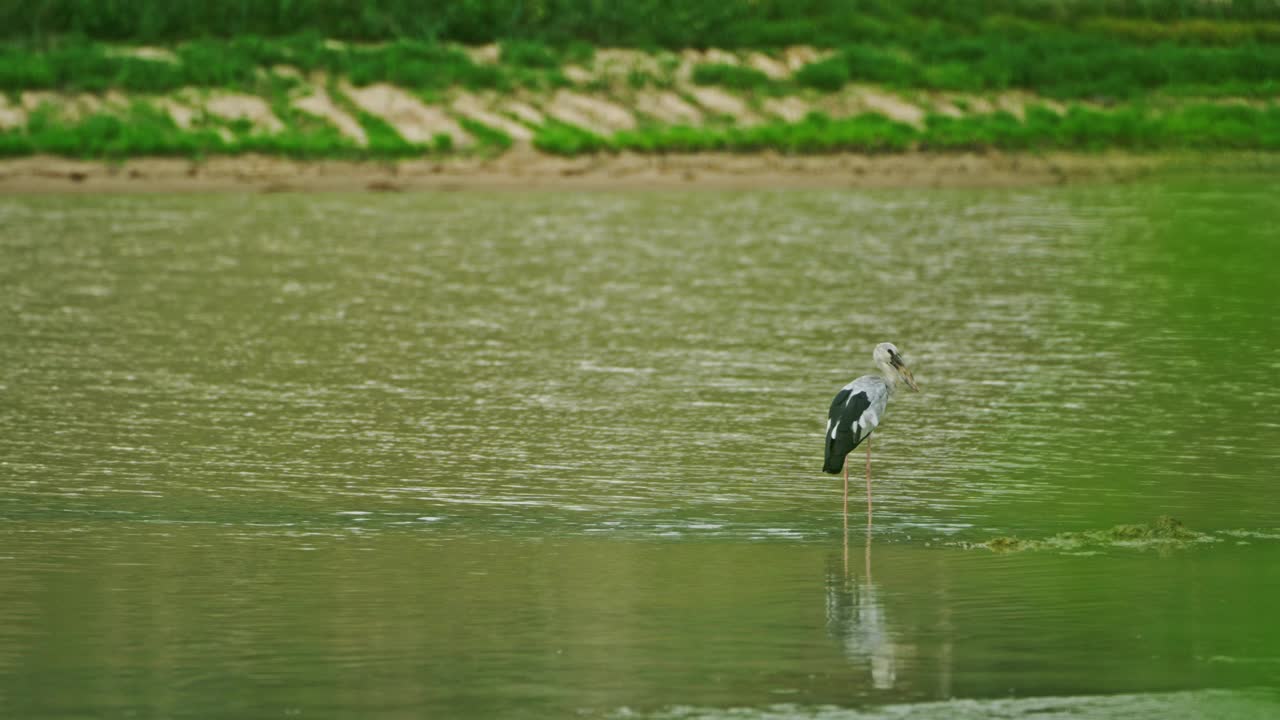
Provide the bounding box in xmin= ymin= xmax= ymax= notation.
xmin=822 ymin=342 xmax=920 ymax=515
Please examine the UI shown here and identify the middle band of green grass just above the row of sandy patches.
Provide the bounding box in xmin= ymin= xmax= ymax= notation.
xmin=0 ymin=32 xmax=1280 ymax=100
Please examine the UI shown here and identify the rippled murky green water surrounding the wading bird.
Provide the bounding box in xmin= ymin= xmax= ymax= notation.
xmin=0 ymin=184 xmax=1280 ymax=720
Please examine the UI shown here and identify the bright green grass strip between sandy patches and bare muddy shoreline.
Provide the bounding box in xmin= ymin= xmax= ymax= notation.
xmin=0 ymin=104 xmax=1280 ymax=159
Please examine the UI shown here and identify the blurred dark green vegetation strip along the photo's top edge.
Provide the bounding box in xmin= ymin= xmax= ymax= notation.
xmin=0 ymin=0 xmax=1280 ymax=49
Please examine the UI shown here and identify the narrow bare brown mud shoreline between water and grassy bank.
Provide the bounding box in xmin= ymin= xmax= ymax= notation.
xmin=0 ymin=150 xmax=1280 ymax=193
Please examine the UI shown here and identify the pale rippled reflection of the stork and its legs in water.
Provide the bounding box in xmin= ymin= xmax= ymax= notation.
xmin=827 ymin=516 xmax=899 ymax=689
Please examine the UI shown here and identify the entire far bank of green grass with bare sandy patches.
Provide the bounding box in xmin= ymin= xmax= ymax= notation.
xmin=0 ymin=0 xmax=1280 ymax=158
